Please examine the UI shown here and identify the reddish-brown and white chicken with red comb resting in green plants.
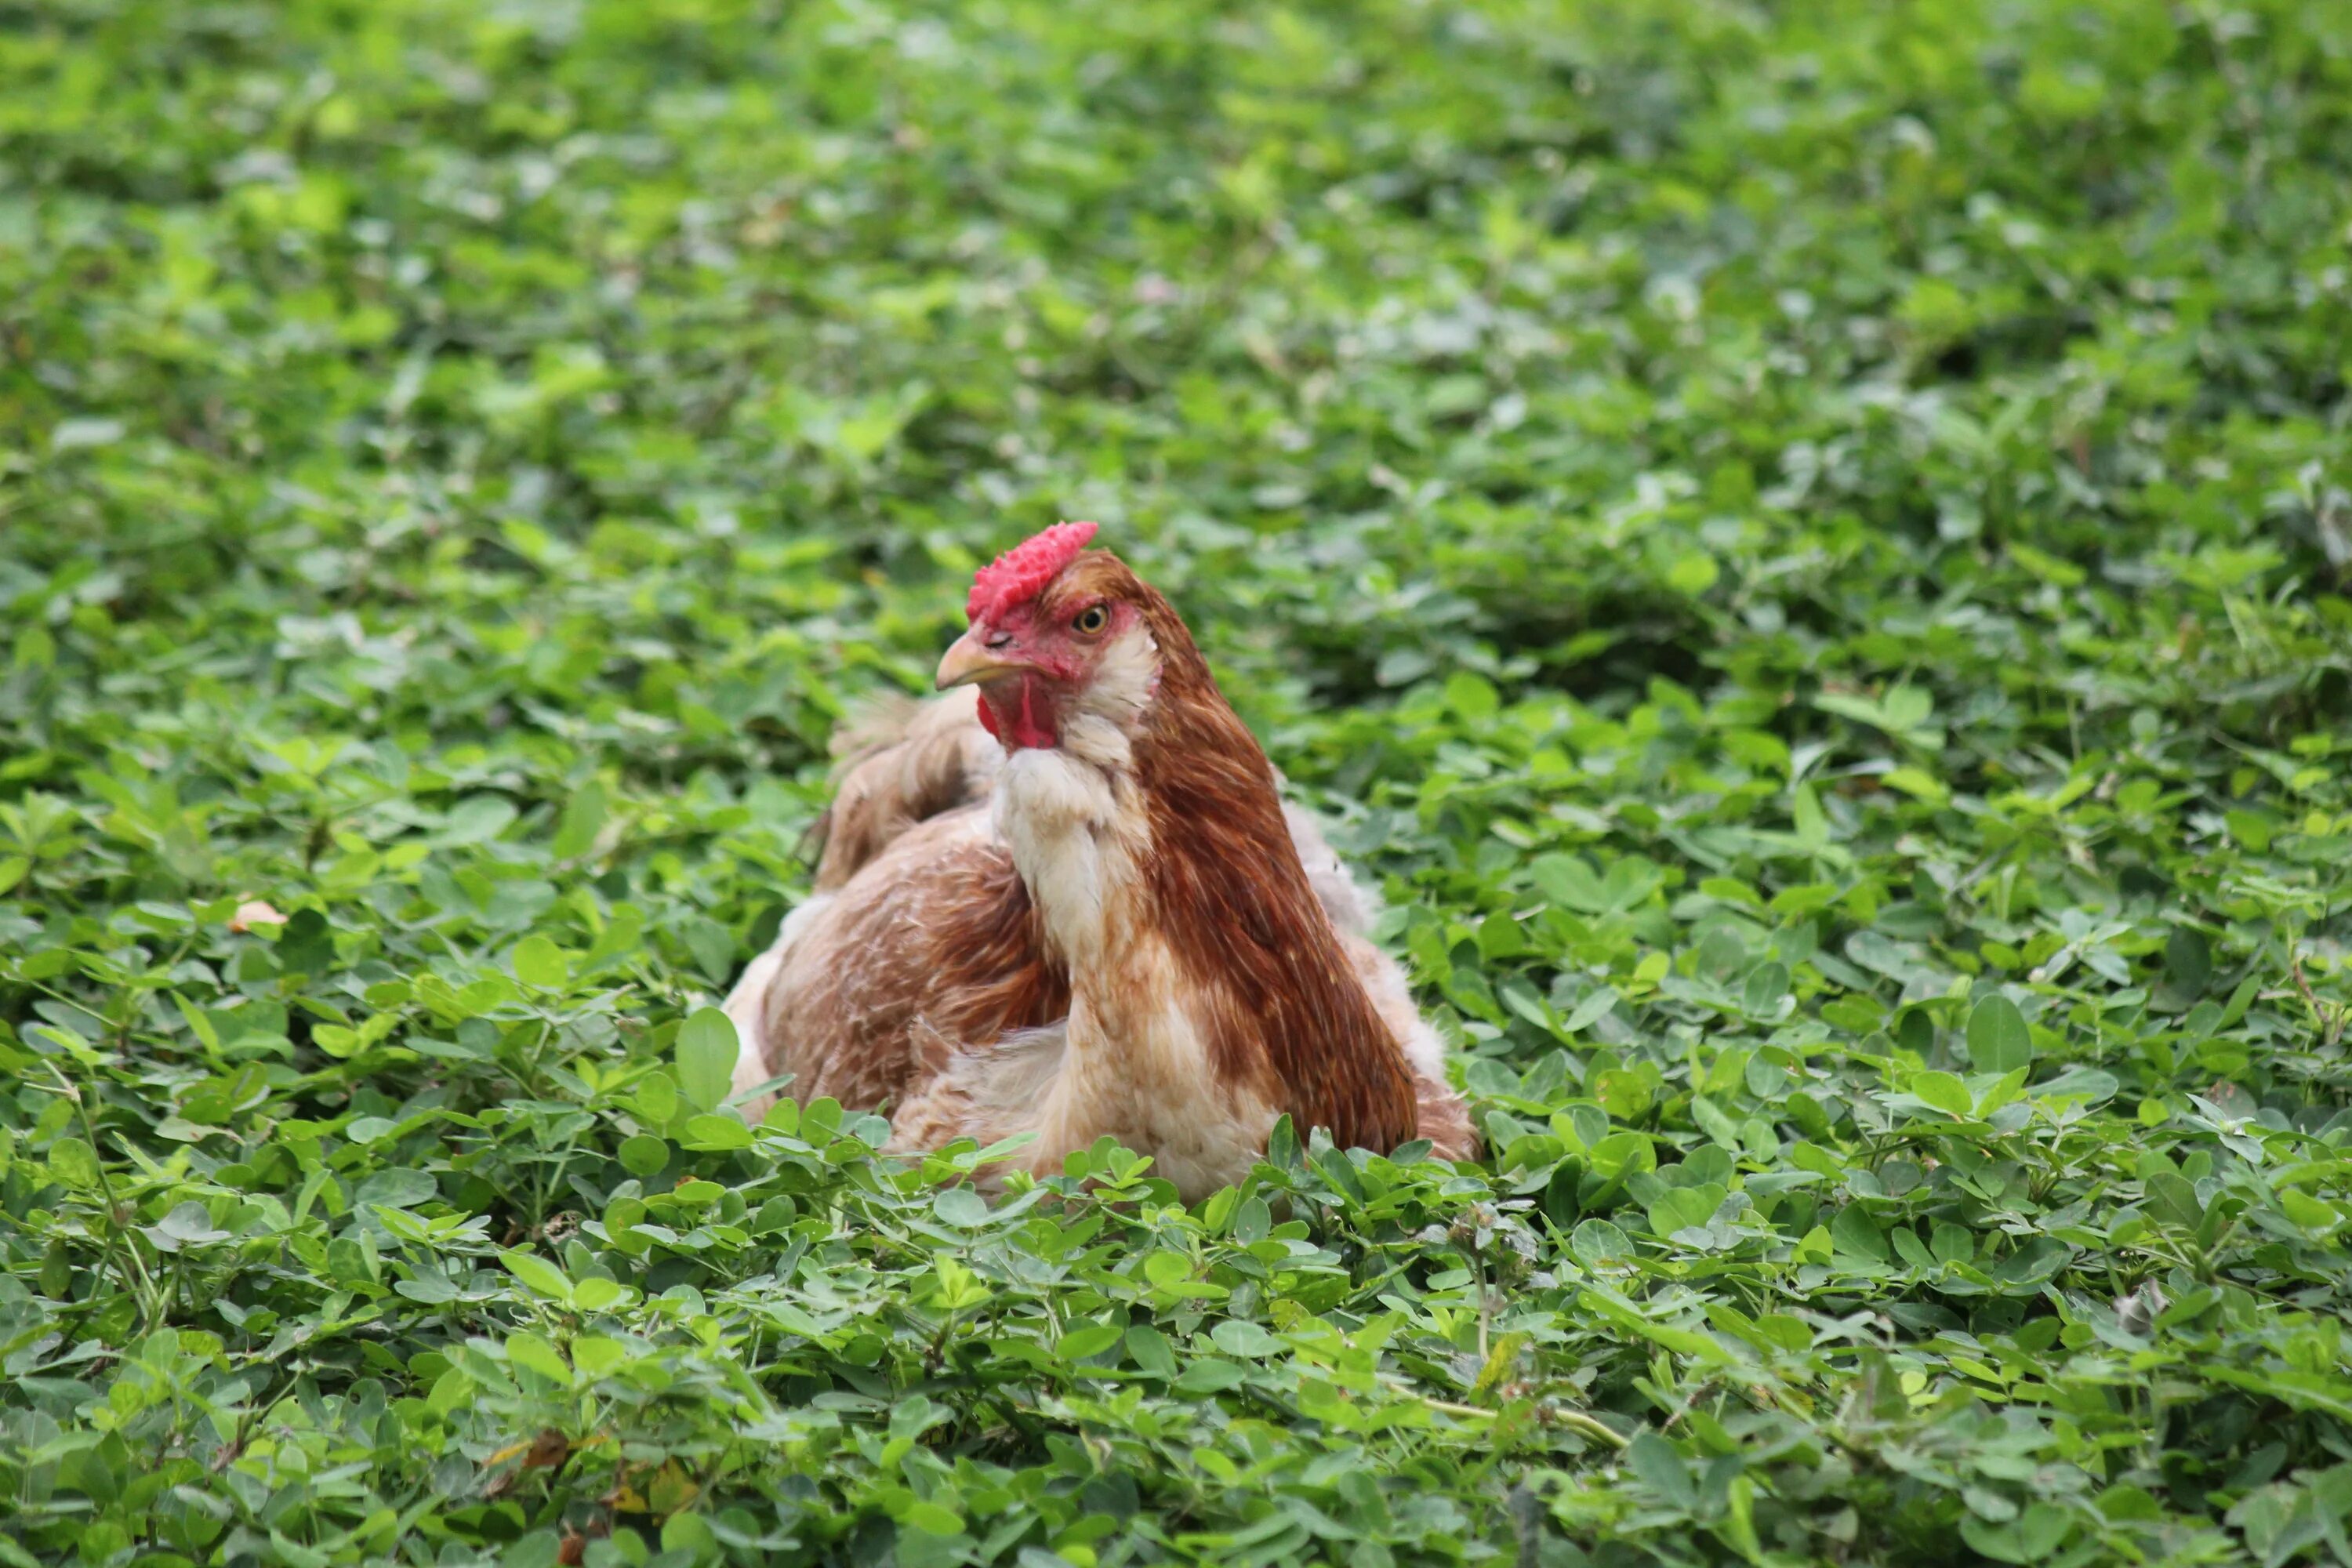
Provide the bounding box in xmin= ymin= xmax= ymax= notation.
xmin=727 ymin=522 xmax=1477 ymax=1201
